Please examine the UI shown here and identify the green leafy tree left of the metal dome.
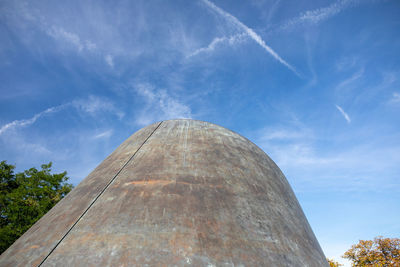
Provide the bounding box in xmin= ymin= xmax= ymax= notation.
xmin=0 ymin=161 xmax=73 ymax=253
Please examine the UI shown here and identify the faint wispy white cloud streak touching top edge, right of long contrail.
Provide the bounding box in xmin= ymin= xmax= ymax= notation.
xmin=280 ymin=0 xmax=362 ymax=30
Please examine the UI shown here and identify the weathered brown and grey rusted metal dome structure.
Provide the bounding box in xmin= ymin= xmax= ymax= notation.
xmin=0 ymin=120 xmax=328 ymax=266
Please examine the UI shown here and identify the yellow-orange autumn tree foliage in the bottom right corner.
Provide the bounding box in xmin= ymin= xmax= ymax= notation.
xmin=343 ymin=237 xmax=400 ymax=267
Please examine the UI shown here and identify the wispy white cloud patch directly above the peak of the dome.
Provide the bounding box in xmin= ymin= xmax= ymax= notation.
xmin=134 ymin=84 xmax=192 ymax=125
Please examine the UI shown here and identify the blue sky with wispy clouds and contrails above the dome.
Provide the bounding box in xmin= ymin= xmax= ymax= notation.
xmin=0 ymin=0 xmax=400 ymax=261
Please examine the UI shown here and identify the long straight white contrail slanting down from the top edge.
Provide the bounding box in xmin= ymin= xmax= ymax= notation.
xmin=203 ymin=0 xmax=300 ymax=76
